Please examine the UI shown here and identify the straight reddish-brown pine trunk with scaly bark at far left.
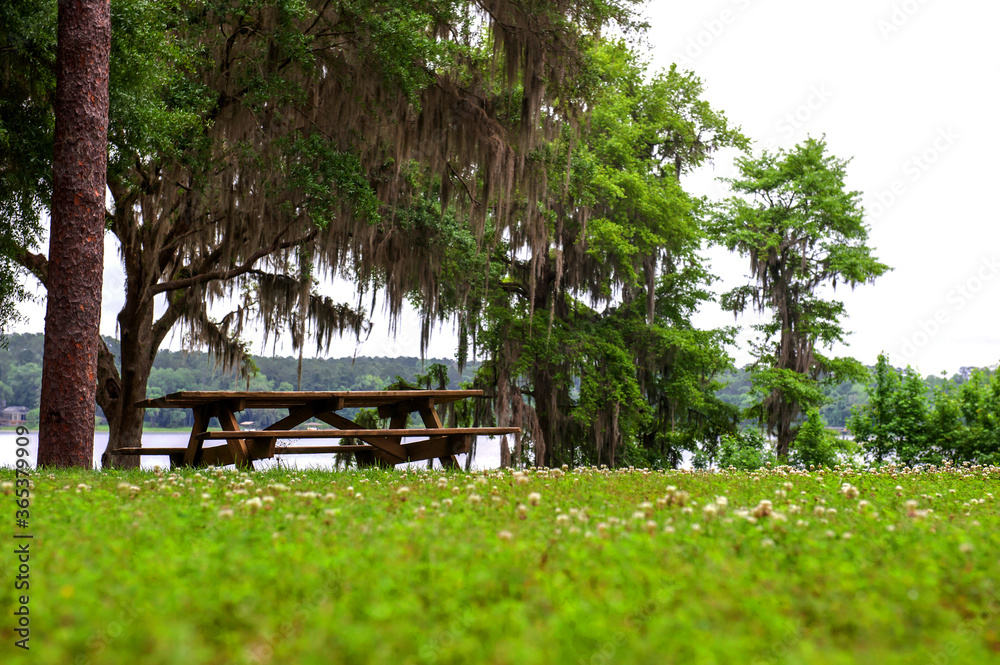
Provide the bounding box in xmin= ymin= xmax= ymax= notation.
xmin=38 ymin=0 xmax=111 ymax=468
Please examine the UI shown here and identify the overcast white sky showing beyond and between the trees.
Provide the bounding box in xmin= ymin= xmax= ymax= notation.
xmin=19 ymin=0 xmax=1000 ymax=374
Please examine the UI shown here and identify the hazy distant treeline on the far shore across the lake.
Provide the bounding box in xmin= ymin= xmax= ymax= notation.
xmin=0 ymin=333 xmax=988 ymax=436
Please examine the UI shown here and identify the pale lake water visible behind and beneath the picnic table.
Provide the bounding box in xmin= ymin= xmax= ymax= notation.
xmin=0 ymin=431 xmax=500 ymax=469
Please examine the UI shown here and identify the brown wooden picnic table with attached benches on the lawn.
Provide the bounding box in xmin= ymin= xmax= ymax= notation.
xmin=117 ymin=390 xmax=520 ymax=468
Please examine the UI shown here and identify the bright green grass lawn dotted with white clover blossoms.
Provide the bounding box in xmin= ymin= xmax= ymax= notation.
xmin=0 ymin=467 xmax=1000 ymax=665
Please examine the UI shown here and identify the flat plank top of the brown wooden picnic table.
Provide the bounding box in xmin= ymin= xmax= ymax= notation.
xmin=136 ymin=390 xmax=484 ymax=410
